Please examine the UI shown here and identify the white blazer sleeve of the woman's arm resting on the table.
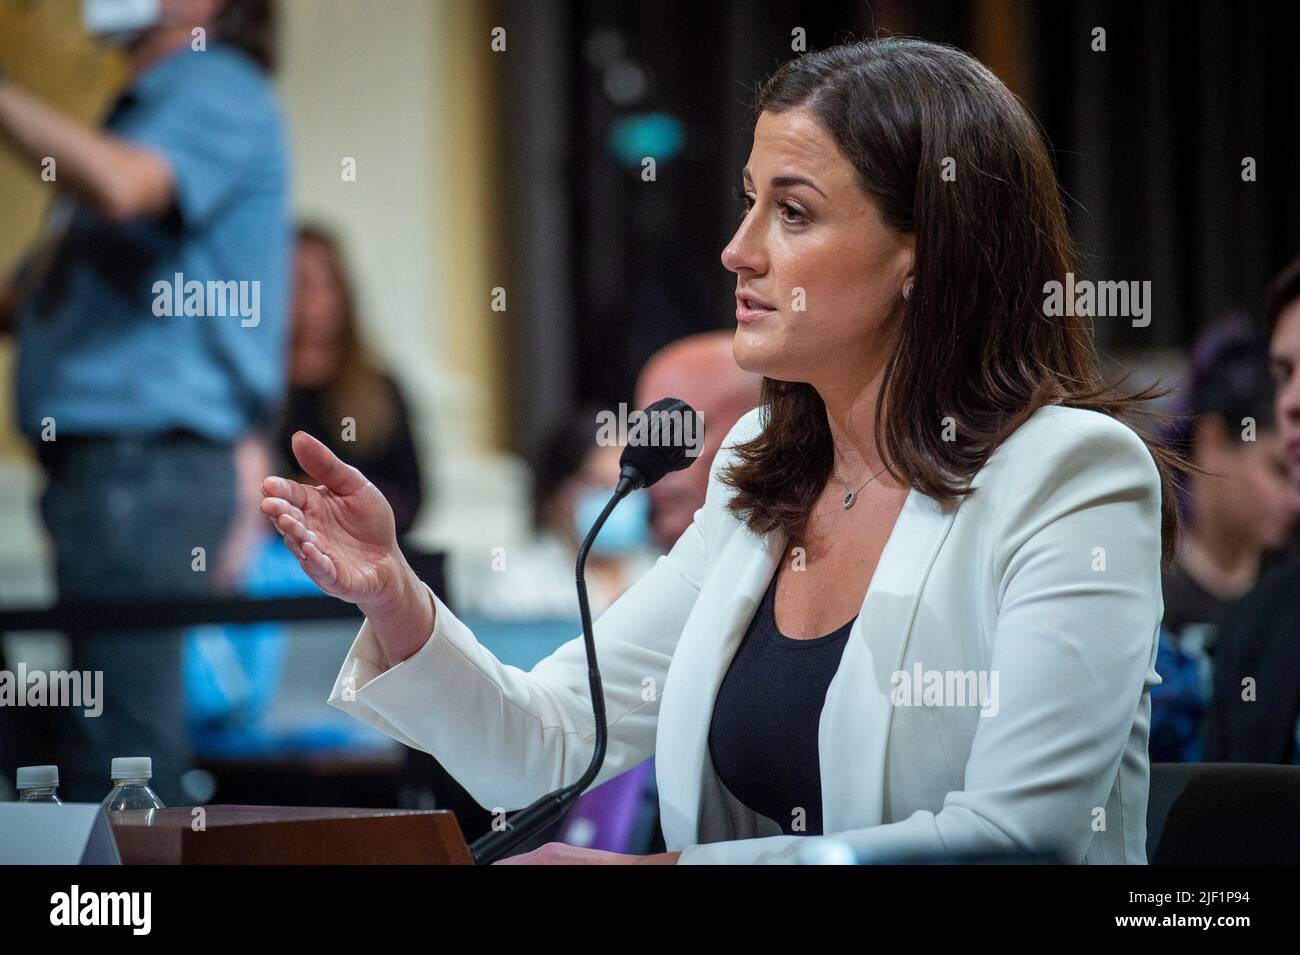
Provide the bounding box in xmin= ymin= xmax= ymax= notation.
xmin=677 ymin=413 xmax=1164 ymax=864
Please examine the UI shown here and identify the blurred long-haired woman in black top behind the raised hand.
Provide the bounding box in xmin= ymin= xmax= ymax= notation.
xmin=275 ymin=225 xmax=423 ymax=537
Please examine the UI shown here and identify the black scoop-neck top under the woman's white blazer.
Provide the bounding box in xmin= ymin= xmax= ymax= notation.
xmin=709 ymin=573 xmax=857 ymax=835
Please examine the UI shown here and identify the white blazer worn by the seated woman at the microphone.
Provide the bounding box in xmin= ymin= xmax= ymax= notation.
xmin=329 ymin=405 xmax=1164 ymax=864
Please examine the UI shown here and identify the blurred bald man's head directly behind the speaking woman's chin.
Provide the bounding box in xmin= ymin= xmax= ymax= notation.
xmin=636 ymin=331 xmax=762 ymax=550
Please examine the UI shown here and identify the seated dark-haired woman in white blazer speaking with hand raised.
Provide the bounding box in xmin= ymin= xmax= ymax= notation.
xmin=263 ymin=38 xmax=1178 ymax=863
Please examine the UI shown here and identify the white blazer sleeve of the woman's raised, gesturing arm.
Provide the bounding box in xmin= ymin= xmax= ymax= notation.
xmin=319 ymin=410 xmax=746 ymax=809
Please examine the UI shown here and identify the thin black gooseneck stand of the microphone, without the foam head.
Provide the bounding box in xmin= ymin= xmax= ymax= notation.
xmin=469 ymin=465 xmax=645 ymax=865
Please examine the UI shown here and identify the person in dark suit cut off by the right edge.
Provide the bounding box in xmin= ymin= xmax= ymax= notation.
xmin=1205 ymin=259 xmax=1300 ymax=763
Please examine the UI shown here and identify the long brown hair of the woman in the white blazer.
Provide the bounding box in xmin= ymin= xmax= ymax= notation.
xmin=722 ymin=36 xmax=1197 ymax=561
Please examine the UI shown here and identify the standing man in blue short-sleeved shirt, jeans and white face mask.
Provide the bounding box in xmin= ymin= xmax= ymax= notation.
xmin=0 ymin=0 xmax=291 ymax=803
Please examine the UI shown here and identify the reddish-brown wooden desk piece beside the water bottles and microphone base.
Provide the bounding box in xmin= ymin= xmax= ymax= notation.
xmin=109 ymin=806 xmax=473 ymax=865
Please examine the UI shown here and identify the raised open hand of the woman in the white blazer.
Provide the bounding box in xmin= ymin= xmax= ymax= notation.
xmin=261 ymin=431 xmax=433 ymax=665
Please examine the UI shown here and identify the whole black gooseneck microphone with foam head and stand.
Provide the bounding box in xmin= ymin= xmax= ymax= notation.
xmin=469 ymin=398 xmax=705 ymax=865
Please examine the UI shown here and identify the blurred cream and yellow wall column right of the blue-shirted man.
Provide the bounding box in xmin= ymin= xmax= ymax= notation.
xmin=280 ymin=0 xmax=504 ymax=459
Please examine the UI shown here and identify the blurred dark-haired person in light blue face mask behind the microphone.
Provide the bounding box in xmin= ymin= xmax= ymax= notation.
xmin=455 ymin=408 xmax=657 ymax=620
